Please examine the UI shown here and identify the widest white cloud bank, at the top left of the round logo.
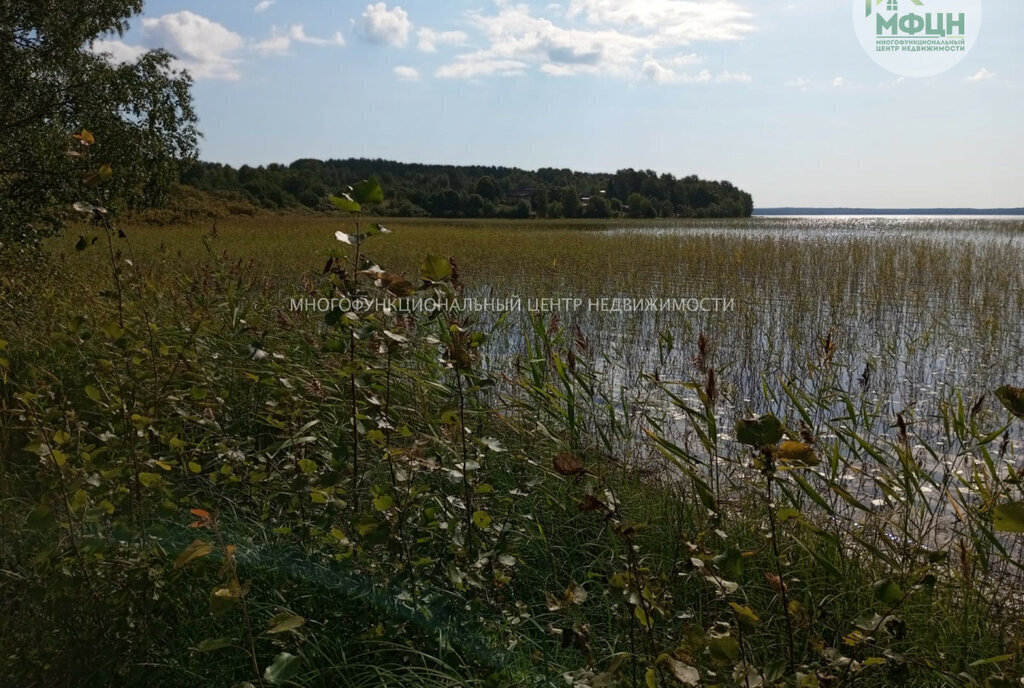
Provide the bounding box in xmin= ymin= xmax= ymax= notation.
xmin=437 ymin=0 xmax=753 ymax=83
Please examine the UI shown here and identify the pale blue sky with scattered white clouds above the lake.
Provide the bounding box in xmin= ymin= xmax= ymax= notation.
xmin=94 ymin=0 xmax=1024 ymax=208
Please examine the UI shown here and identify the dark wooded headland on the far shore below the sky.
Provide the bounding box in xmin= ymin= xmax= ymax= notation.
xmin=181 ymin=159 xmax=754 ymax=219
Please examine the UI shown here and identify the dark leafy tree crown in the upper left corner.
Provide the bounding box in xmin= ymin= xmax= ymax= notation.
xmin=0 ymin=0 xmax=198 ymax=244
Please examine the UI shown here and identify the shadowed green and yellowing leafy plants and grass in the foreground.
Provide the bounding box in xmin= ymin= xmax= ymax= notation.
xmin=0 ymin=167 xmax=1024 ymax=688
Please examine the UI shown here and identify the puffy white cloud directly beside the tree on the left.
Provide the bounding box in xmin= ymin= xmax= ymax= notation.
xmin=92 ymin=10 xmax=244 ymax=81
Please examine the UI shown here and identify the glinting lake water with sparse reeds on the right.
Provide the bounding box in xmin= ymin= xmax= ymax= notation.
xmin=475 ymin=216 xmax=1024 ymax=481
